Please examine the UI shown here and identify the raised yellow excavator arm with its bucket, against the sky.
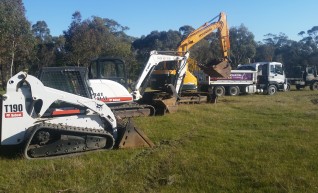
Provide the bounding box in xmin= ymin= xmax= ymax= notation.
xmin=178 ymin=12 xmax=231 ymax=77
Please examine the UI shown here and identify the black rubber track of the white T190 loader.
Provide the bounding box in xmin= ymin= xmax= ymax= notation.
xmin=24 ymin=123 xmax=115 ymax=159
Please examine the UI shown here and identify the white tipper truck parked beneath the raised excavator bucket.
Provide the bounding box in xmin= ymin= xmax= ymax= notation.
xmin=199 ymin=62 xmax=290 ymax=96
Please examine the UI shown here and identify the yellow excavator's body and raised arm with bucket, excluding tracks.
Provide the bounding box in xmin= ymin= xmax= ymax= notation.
xmin=151 ymin=12 xmax=231 ymax=91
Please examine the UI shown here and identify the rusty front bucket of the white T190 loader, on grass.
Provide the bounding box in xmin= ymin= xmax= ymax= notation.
xmin=116 ymin=119 xmax=155 ymax=149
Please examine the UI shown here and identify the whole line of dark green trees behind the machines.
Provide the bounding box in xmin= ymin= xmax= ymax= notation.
xmin=0 ymin=0 xmax=318 ymax=87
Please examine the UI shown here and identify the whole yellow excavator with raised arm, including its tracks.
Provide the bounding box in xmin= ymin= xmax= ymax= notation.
xmin=151 ymin=12 xmax=231 ymax=103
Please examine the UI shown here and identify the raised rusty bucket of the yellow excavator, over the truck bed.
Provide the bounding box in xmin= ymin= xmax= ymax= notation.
xmin=199 ymin=60 xmax=231 ymax=77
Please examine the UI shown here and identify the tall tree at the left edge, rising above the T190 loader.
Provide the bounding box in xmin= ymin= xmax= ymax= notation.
xmin=0 ymin=0 xmax=33 ymax=86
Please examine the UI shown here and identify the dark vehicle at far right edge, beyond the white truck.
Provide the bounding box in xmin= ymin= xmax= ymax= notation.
xmin=287 ymin=66 xmax=318 ymax=90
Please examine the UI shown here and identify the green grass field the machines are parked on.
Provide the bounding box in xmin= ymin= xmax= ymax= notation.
xmin=0 ymin=90 xmax=318 ymax=193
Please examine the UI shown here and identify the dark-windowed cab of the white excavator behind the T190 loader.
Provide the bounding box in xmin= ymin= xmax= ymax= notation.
xmin=88 ymin=57 xmax=127 ymax=88
